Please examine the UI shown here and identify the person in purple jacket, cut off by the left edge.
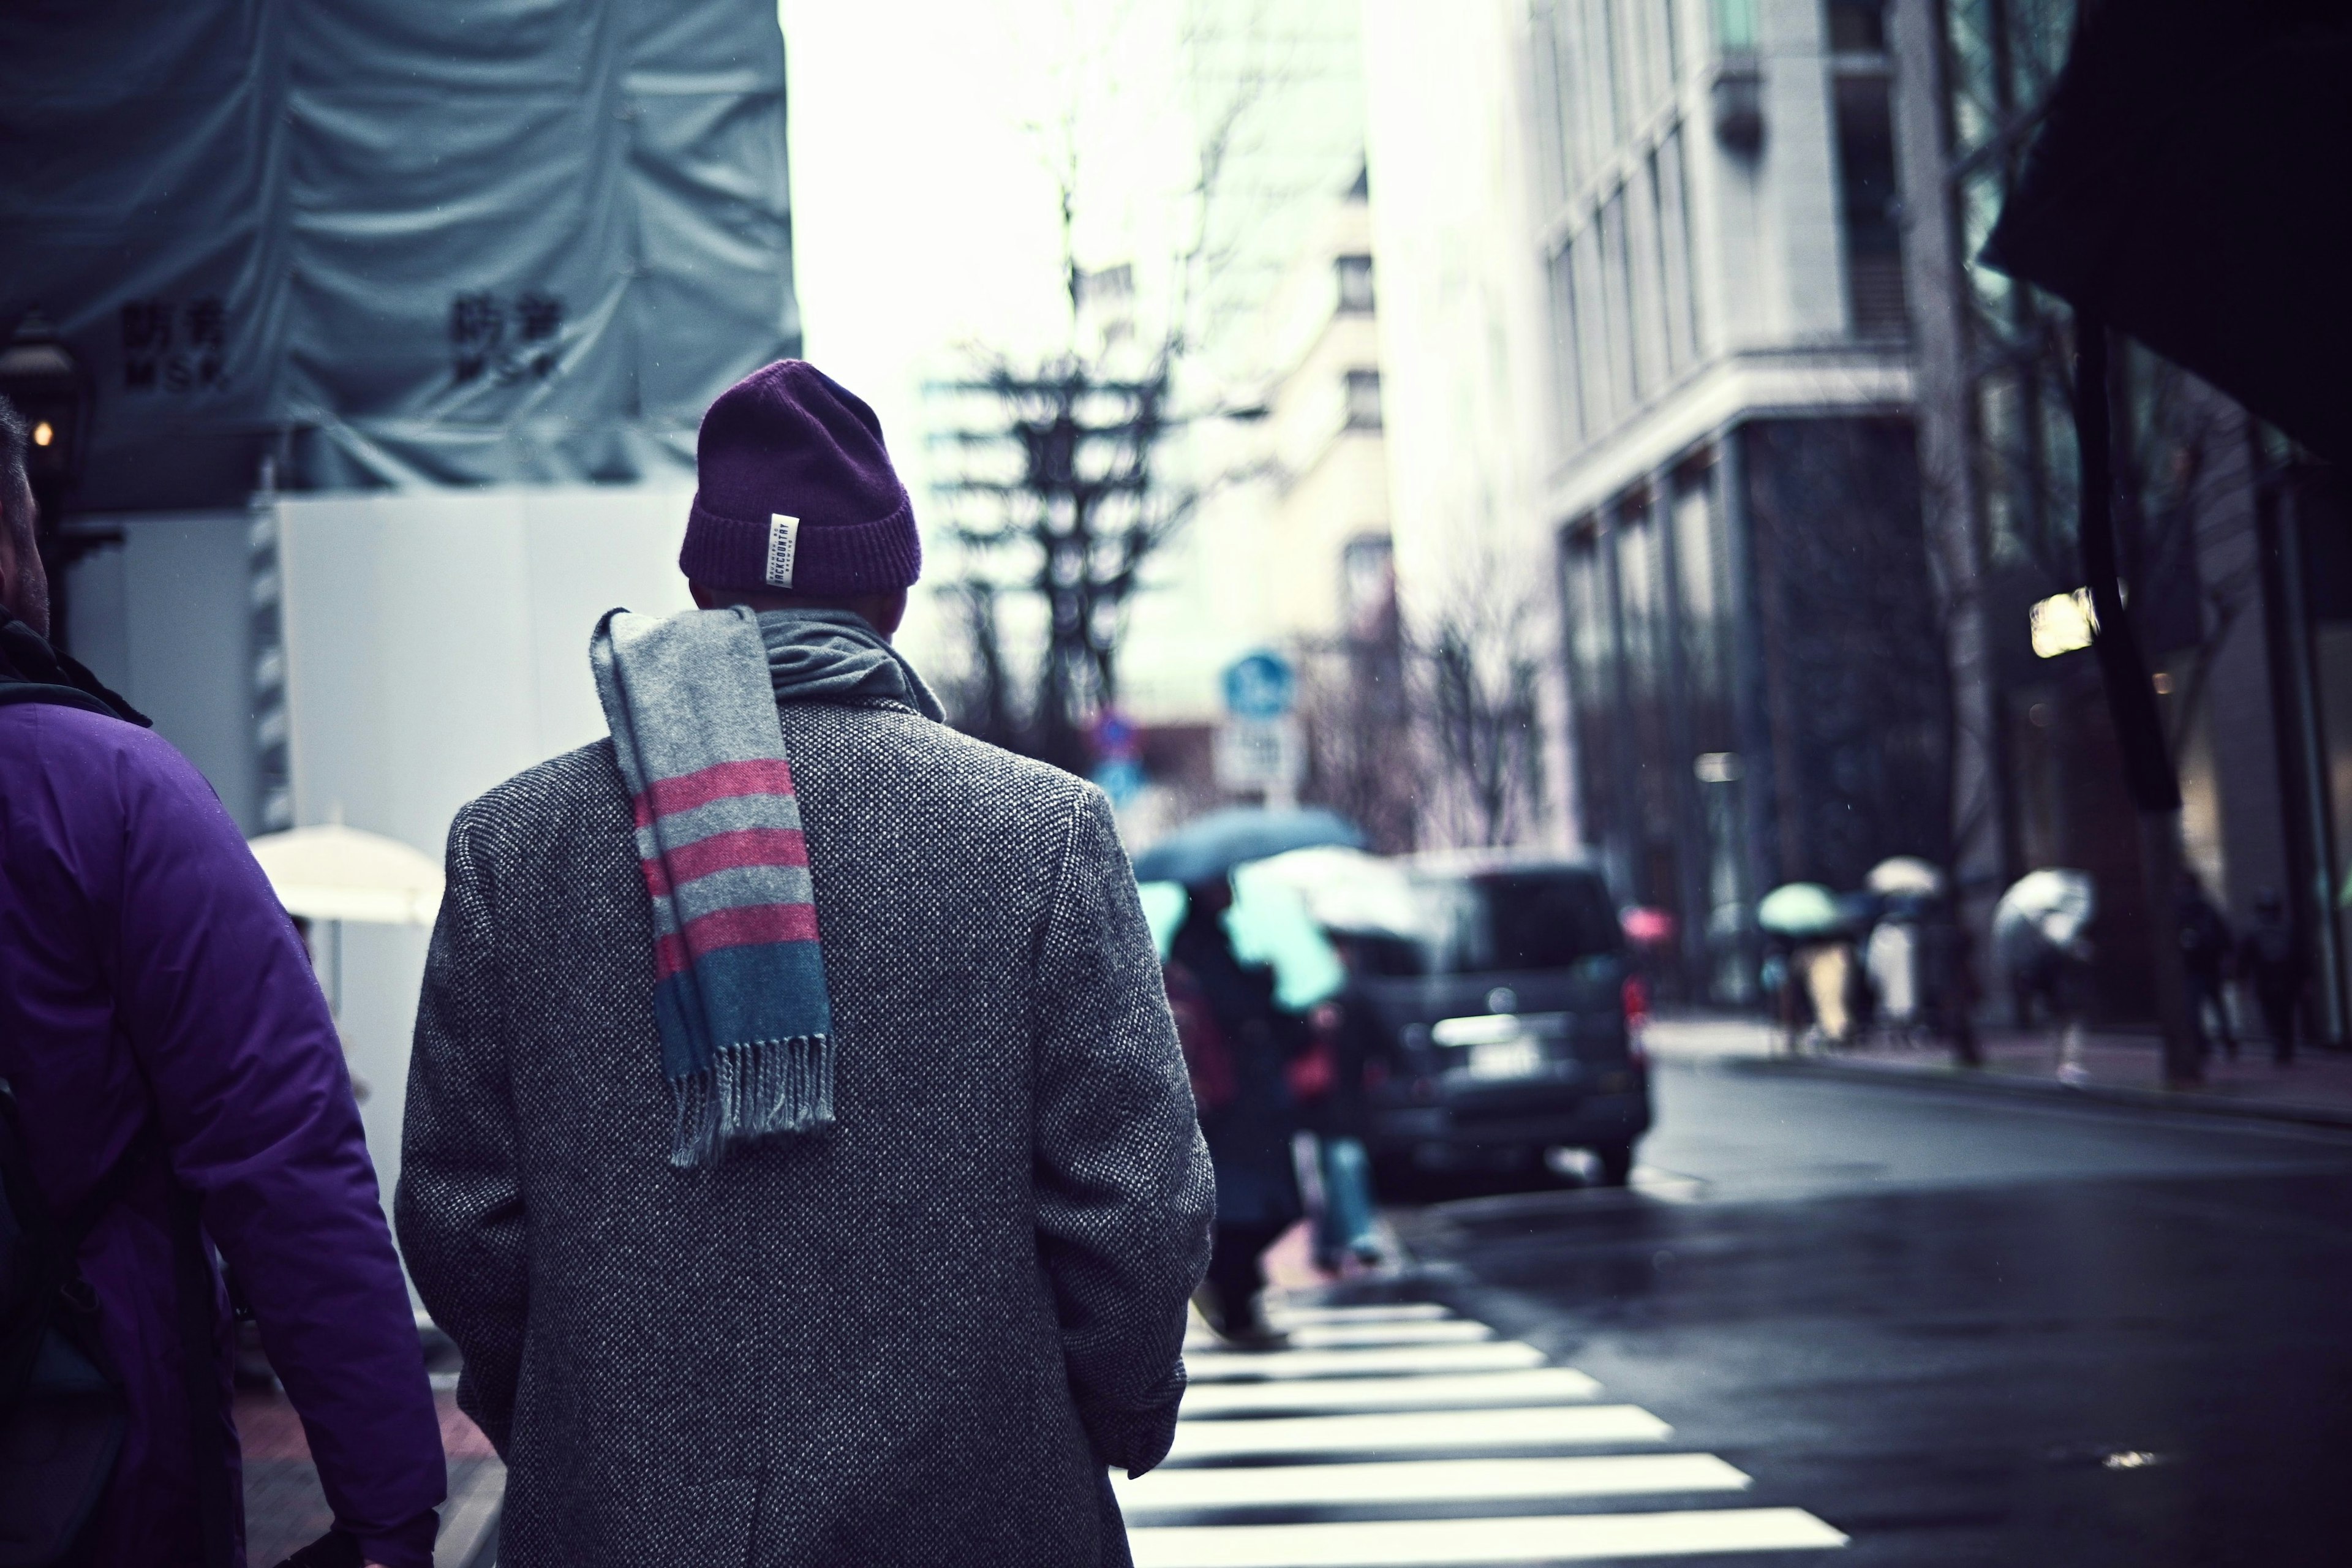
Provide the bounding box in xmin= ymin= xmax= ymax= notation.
xmin=0 ymin=399 xmax=447 ymax=1568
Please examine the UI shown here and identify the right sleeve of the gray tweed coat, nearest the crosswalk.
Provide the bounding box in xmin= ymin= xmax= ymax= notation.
xmin=1033 ymin=785 xmax=1216 ymax=1474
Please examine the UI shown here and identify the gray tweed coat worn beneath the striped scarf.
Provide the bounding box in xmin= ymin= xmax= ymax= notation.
xmin=395 ymin=703 xmax=1213 ymax=1568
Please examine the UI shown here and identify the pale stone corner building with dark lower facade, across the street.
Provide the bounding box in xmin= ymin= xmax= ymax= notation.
xmin=1524 ymin=0 xmax=1950 ymax=1001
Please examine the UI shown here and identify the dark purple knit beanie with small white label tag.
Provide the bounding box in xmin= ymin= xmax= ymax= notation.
xmin=677 ymin=360 xmax=922 ymax=595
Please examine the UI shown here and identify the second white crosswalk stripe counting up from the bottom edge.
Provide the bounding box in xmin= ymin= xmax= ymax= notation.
xmin=1112 ymin=1453 xmax=1747 ymax=1518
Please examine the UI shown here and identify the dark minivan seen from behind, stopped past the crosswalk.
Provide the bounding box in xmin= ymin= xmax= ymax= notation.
xmin=1357 ymin=858 xmax=1651 ymax=1185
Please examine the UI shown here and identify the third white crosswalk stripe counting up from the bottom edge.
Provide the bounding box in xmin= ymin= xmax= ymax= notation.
xmin=1169 ymin=1406 xmax=1675 ymax=1464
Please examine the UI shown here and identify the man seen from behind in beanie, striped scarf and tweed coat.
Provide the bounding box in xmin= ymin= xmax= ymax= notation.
xmin=398 ymin=360 xmax=1212 ymax=1568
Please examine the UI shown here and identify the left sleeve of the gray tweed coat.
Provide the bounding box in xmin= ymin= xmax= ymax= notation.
xmin=393 ymin=811 xmax=529 ymax=1455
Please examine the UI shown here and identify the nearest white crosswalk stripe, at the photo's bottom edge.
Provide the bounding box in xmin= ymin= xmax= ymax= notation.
xmin=1126 ymin=1509 xmax=1846 ymax=1568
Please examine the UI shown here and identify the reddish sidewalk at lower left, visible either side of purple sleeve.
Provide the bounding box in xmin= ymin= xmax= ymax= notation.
xmin=235 ymin=1389 xmax=506 ymax=1568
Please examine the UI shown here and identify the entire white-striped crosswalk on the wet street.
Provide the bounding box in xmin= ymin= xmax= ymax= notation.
xmin=1147 ymin=1298 xmax=1846 ymax=1568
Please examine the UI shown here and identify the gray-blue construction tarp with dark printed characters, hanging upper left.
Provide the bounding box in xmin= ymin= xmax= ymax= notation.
xmin=0 ymin=0 xmax=800 ymax=513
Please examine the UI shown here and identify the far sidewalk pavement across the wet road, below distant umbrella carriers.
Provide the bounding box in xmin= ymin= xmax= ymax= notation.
xmin=1644 ymin=1013 xmax=2352 ymax=1126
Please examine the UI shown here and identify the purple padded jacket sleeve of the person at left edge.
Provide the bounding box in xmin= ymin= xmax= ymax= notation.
xmin=113 ymin=741 xmax=447 ymax=1568
